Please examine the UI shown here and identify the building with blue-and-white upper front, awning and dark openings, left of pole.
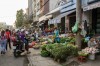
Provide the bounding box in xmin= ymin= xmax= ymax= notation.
xmin=49 ymin=0 xmax=76 ymax=33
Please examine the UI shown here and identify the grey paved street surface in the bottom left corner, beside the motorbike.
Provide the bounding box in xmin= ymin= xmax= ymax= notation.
xmin=0 ymin=50 xmax=25 ymax=66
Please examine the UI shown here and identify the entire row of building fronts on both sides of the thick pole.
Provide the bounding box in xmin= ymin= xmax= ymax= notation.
xmin=29 ymin=0 xmax=100 ymax=33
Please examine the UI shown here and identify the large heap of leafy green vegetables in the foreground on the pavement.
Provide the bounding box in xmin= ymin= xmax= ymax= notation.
xmin=41 ymin=43 xmax=78 ymax=60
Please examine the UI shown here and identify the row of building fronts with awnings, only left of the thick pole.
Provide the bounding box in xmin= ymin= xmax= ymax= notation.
xmin=27 ymin=0 xmax=76 ymax=33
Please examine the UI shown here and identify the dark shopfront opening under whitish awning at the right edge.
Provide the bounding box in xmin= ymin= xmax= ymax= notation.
xmin=83 ymin=0 xmax=100 ymax=34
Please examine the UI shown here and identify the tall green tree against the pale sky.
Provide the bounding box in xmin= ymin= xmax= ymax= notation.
xmin=15 ymin=9 xmax=24 ymax=28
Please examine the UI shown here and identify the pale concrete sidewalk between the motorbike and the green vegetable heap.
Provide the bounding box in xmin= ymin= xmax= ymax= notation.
xmin=28 ymin=49 xmax=62 ymax=66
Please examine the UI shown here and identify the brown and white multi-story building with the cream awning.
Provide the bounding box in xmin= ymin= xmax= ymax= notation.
xmin=39 ymin=0 xmax=65 ymax=29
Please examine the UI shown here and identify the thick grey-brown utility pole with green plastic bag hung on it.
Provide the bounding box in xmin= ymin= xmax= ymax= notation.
xmin=76 ymin=0 xmax=82 ymax=49
